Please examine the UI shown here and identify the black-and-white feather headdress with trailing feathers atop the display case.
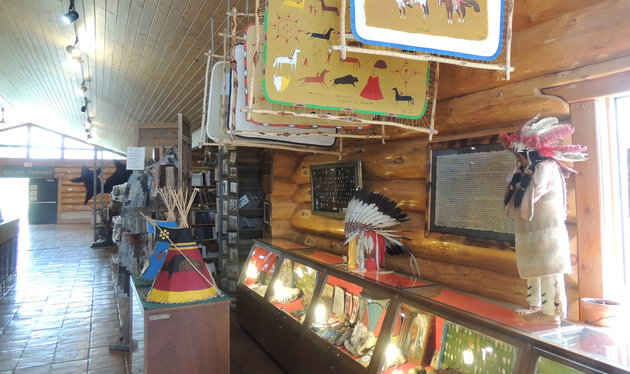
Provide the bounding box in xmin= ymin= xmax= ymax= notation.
xmin=344 ymin=188 xmax=420 ymax=276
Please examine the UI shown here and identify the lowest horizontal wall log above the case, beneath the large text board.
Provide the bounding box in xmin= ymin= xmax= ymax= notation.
xmin=384 ymin=256 xmax=527 ymax=306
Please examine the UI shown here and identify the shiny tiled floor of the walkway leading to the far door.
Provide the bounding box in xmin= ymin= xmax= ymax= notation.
xmin=0 ymin=225 xmax=125 ymax=374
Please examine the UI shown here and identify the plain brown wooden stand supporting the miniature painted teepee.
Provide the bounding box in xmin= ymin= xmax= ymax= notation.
xmin=132 ymin=282 xmax=230 ymax=374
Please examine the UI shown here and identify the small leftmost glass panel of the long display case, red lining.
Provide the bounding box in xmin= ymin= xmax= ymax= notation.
xmin=241 ymin=246 xmax=278 ymax=297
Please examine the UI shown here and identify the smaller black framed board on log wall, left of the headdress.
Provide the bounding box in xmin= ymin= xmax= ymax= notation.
xmin=311 ymin=161 xmax=362 ymax=218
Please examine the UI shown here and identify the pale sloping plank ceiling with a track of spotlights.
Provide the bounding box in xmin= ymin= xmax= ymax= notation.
xmin=0 ymin=0 xmax=254 ymax=151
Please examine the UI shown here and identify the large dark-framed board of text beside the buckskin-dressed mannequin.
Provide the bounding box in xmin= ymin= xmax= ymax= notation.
xmin=428 ymin=143 xmax=516 ymax=243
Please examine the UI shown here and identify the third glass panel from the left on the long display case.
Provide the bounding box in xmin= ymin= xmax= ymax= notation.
xmin=310 ymin=276 xmax=390 ymax=367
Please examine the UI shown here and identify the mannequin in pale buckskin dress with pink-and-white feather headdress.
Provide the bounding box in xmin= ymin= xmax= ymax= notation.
xmin=503 ymin=118 xmax=586 ymax=323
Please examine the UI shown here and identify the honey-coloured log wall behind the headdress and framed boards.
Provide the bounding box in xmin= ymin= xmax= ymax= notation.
xmin=268 ymin=0 xmax=630 ymax=320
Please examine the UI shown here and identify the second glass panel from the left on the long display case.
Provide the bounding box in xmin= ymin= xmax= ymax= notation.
xmin=269 ymin=258 xmax=319 ymax=323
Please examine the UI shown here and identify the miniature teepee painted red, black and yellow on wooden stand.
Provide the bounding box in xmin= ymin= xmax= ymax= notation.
xmin=146 ymin=190 xmax=221 ymax=304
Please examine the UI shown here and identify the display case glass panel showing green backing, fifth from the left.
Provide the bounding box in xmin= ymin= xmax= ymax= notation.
xmin=439 ymin=321 xmax=517 ymax=374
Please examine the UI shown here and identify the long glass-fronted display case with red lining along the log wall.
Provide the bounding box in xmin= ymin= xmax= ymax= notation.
xmin=236 ymin=239 xmax=630 ymax=374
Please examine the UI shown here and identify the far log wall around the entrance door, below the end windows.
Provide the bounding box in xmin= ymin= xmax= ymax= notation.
xmin=0 ymin=159 xmax=116 ymax=224
